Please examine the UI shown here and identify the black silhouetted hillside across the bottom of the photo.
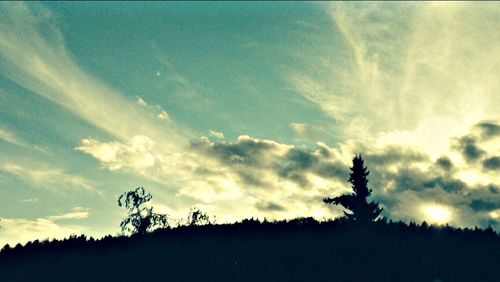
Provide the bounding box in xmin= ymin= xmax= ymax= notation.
xmin=0 ymin=219 xmax=500 ymax=282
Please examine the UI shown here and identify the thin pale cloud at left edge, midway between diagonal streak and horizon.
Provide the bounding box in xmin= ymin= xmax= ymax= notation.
xmin=0 ymin=163 xmax=95 ymax=191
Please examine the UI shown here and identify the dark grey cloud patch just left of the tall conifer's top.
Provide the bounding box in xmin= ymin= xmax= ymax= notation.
xmin=191 ymin=136 xmax=348 ymax=188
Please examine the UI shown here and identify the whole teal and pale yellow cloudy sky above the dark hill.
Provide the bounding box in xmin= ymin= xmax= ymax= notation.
xmin=0 ymin=2 xmax=500 ymax=245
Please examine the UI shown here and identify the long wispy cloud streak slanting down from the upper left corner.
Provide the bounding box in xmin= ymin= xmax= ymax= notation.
xmin=0 ymin=3 xmax=186 ymax=148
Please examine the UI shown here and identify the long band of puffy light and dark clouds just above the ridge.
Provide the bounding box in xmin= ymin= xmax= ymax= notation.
xmin=73 ymin=120 xmax=500 ymax=230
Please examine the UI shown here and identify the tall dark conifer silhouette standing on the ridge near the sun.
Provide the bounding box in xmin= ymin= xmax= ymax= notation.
xmin=323 ymin=155 xmax=382 ymax=222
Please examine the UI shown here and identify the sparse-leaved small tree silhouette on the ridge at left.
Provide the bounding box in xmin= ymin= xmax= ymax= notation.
xmin=118 ymin=187 xmax=169 ymax=234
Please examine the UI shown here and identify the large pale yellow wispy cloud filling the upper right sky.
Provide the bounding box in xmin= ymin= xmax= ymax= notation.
xmin=287 ymin=2 xmax=500 ymax=156
